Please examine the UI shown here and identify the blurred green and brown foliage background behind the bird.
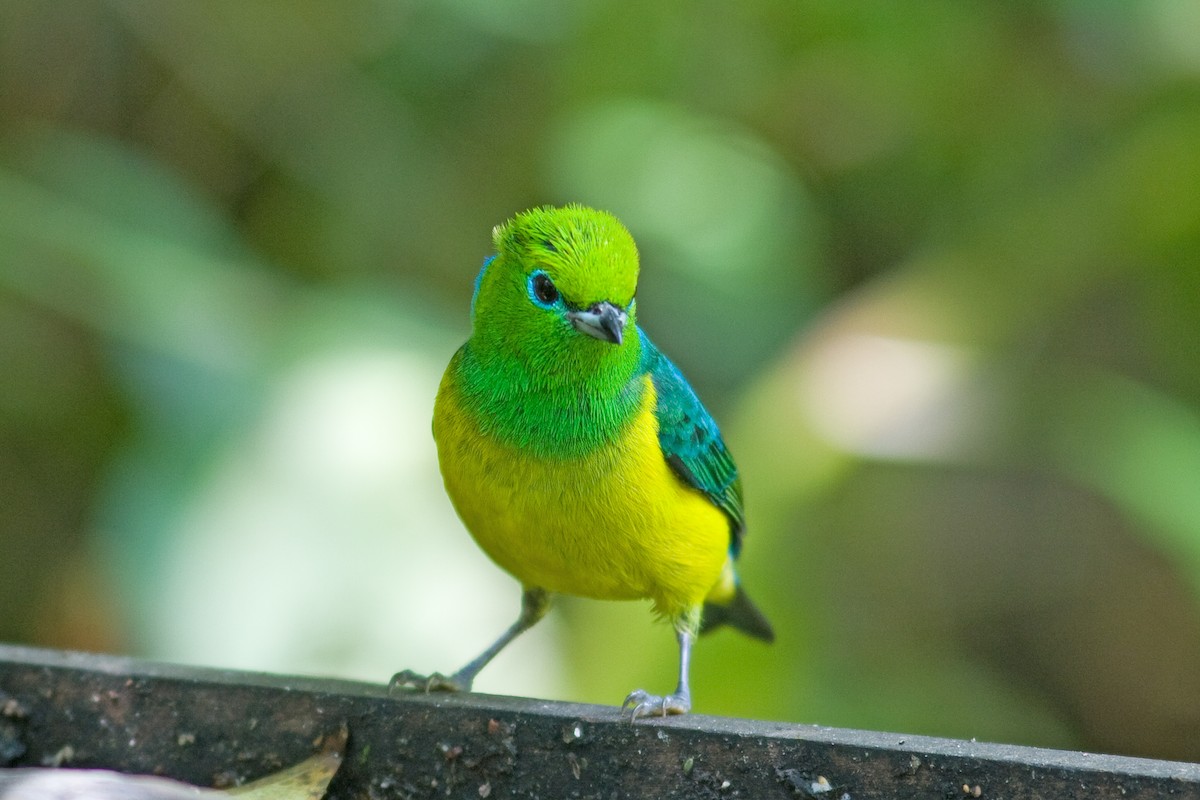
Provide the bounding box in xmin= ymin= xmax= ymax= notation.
xmin=0 ymin=0 xmax=1200 ymax=759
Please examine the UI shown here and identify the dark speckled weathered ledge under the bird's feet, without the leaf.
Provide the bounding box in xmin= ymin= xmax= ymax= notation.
xmin=0 ymin=645 xmax=1200 ymax=800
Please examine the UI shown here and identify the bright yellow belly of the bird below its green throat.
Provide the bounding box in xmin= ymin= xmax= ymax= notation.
xmin=433 ymin=373 xmax=730 ymax=616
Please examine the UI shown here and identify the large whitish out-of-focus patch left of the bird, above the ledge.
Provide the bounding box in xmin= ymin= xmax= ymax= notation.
xmin=151 ymin=350 xmax=564 ymax=697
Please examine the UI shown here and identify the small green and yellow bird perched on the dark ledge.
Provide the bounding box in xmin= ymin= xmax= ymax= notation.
xmin=389 ymin=204 xmax=775 ymax=721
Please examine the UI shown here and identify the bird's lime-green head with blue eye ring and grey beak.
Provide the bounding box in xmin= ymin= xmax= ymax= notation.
xmin=472 ymin=205 xmax=640 ymax=381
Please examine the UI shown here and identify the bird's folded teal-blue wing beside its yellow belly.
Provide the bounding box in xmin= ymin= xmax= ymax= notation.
xmin=638 ymin=329 xmax=745 ymax=557
